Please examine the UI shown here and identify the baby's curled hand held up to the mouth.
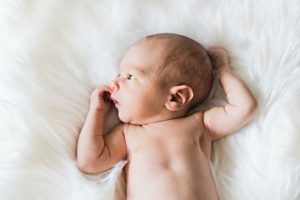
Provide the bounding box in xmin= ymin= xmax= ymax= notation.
xmin=90 ymin=85 xmax=112 ymax=114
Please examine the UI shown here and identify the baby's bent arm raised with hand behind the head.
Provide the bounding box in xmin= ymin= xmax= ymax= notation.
xmin=204 ymin=47 xmax=257 ymax=139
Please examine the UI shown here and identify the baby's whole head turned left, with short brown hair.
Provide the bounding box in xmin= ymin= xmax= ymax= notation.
xmin=112 ymin=33 xmax=213 ymax=124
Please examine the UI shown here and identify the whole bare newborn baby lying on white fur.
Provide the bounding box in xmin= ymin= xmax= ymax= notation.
xmin=77 ymin=33 xmax=256 ymax=200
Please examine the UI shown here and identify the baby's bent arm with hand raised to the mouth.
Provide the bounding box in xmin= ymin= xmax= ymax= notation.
xmin=77 ymin=86 xmax=126 ymax=173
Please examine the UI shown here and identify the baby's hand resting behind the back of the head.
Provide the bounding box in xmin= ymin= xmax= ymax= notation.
xmin=207 ymin=46 xmax=229 ymax=71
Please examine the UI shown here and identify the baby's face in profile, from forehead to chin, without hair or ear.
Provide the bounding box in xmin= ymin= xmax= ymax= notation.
xmin=111 ymin=40 xmax=167 ymax=124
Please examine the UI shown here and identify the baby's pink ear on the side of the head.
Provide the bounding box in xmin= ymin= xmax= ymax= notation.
xmin=165 ymin=85 xmax=194 ymax=111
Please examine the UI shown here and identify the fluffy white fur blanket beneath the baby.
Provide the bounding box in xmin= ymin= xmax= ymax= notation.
xmin=0 ymin=0 xmax=300 ymax=200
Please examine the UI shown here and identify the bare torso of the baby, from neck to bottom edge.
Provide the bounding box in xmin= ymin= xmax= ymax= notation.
xmin=125 ymin=114 xmax=218 ymax=200
